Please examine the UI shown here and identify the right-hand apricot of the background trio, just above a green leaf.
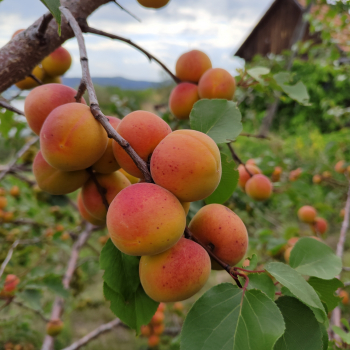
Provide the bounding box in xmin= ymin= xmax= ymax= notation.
xmin=198 ymin=68 xmax=236 ymax=100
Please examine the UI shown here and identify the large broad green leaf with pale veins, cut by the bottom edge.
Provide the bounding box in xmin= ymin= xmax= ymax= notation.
xmin=181 ymin=283 xmax=284 ymax=350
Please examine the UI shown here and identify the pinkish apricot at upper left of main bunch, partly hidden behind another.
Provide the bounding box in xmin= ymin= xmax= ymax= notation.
xmin=24 ymin=84 xmax=86 ymax=135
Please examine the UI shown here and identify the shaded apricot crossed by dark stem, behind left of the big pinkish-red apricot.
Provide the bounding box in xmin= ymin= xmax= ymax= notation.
xmin=81 ymin=171 xmax=131 ymax=221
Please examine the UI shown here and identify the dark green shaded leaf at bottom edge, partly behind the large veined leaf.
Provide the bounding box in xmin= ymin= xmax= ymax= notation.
xmin=274 ymin=297 xmax=323 ymax=350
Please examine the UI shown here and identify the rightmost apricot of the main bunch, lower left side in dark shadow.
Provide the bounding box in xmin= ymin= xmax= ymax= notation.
xmin=188 ymin=204 xmax=249 ymax=265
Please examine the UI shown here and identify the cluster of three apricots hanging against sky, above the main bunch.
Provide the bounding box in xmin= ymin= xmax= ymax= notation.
xmin=169 ymin=50 xmax=236 ymax=119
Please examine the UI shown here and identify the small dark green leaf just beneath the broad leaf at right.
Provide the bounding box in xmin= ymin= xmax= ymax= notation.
xmin=308 ymin=277 xmax=344 ymax=311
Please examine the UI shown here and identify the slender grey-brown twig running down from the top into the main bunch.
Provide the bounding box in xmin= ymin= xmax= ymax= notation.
xmin=60 ymin=6 xmax=152 ymax=182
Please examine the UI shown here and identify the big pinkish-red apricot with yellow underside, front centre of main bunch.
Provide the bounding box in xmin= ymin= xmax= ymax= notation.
xmin=107 ymin=183 xmax=186 ymax=256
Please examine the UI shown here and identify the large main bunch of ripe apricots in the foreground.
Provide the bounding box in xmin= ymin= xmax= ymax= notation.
xmin=24 ymin=80 xmax=248 ymax=302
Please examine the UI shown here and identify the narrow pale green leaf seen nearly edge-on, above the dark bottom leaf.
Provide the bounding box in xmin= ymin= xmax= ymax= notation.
xmin=265 ymin=262 xmax=327 ymax=323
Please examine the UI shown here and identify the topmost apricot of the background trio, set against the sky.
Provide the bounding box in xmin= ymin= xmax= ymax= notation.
xmin=175 ymin=50 xmax=212 ymax=83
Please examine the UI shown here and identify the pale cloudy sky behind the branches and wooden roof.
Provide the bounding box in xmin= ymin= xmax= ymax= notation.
xmin=0 ymin=0 xmax=273 ymax=81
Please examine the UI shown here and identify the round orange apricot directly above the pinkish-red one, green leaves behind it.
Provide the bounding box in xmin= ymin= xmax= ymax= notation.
xmin=151 ymin=130 xmax=221 ymax=202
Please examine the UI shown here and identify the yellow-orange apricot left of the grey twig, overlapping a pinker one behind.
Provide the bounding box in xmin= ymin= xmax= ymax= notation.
xmin=40 ymin=103 xmax=108 ymax=171
